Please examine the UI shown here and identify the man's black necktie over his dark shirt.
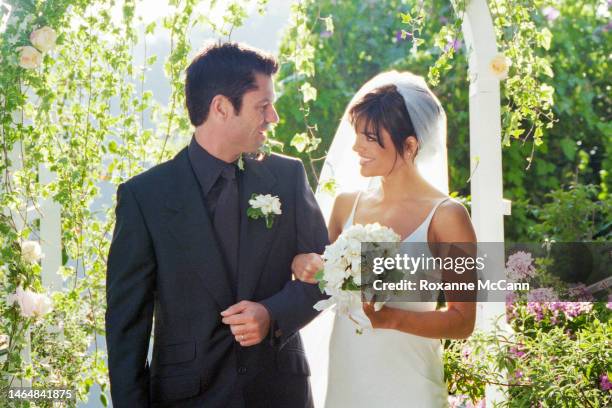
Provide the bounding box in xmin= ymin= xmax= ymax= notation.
xmin=213 ymin=165 xmax=240 ymax=287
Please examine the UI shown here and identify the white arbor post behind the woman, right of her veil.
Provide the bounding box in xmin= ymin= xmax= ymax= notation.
xmin=463 ymin=0 xmax=510 ymax=405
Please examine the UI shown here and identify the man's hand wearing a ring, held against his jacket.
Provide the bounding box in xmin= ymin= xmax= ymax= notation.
xmin=221 ymin=300 xmax=270 ymax=347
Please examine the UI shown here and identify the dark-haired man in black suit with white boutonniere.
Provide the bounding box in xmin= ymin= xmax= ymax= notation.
xmin=106 ymin=43 xmax=327 ymax=408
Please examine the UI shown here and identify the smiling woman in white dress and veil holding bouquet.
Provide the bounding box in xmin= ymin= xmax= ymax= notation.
xmin=292 ymin=72 xmax=476 ymax=408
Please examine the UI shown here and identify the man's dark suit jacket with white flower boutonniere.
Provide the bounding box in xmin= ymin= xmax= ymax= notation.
xmin=106 ymin=149 xmax=328 ymax=408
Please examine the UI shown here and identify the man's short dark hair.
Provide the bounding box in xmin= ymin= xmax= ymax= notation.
xmin=185 ymin=42 xmax=278 ymax=126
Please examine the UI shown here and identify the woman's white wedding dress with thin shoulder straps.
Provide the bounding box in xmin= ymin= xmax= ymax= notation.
xmin=325 ymin=195 xmax=448 ymax=408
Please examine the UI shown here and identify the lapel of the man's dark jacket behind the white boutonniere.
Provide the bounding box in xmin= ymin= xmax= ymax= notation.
xmin=238 ymin=159 xmax=282 ymax=301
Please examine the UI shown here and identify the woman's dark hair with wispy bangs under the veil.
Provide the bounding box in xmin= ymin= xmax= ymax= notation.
xmin=349 ymin=85 xmax=416 ymax=157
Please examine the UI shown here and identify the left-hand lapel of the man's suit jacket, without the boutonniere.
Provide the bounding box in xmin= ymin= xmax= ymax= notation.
xmin=166 ymin=148 xmax=235 ymax=310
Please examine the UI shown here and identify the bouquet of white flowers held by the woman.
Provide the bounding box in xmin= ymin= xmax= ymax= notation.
xmin=314 ymin=223 xmax=400 ymax=333
